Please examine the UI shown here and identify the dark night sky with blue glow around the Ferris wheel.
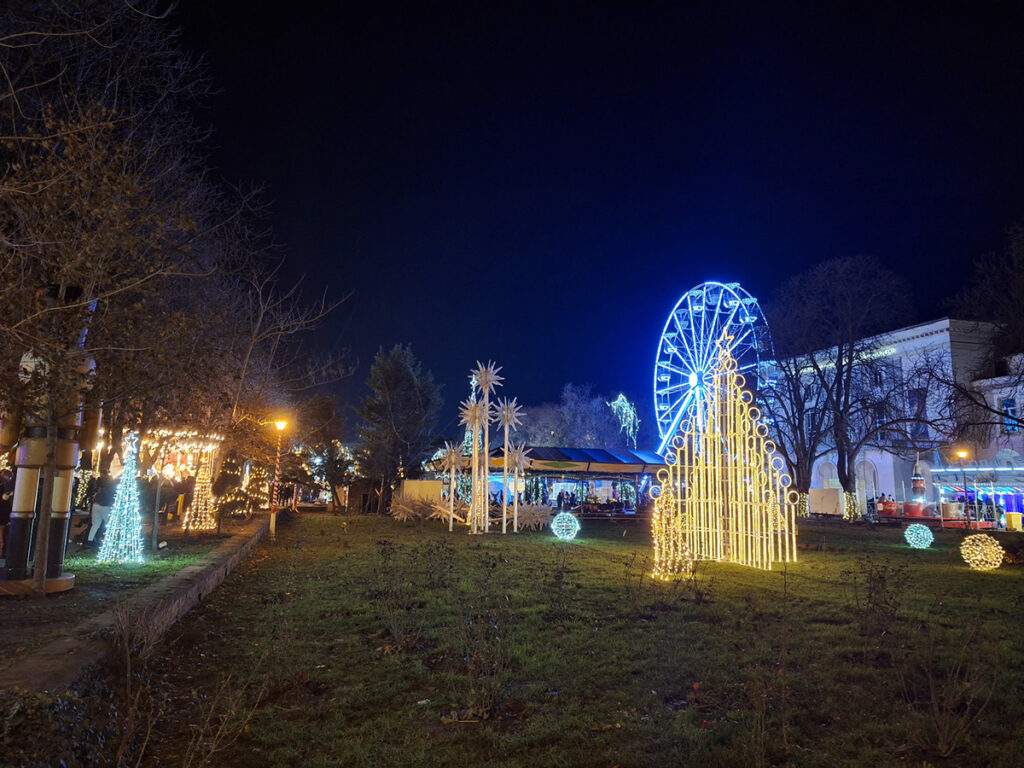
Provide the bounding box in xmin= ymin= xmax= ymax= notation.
xmin=177 ymin=0 xmax=1024 ymax=435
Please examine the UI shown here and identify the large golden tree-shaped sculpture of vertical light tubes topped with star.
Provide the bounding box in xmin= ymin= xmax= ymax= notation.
xmin=652 ymin=337 xmax=797 ymax=578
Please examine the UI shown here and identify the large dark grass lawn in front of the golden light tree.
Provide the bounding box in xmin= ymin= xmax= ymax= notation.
xmin=144 ymin=515 xmax=1024 ymax=768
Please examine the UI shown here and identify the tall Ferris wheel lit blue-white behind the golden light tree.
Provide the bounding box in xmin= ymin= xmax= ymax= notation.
xmin=654 ymin=283 xmax=772 ymax=454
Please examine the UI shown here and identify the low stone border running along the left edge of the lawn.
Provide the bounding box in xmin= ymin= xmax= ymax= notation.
xmin=0 ymin=521 xmax=269 ymax=694
